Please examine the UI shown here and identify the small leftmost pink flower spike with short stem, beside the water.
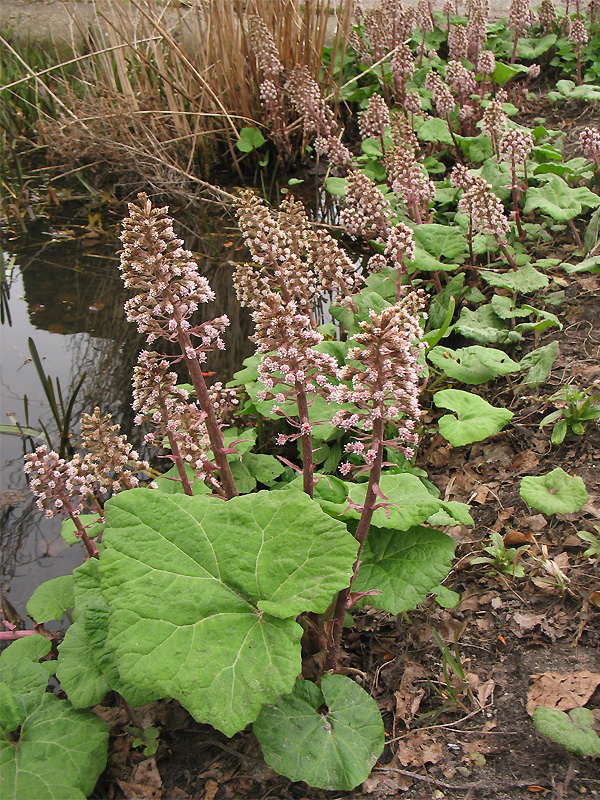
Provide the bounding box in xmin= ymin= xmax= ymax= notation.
xmin=24 ymin=445 xmax=98 ymax=558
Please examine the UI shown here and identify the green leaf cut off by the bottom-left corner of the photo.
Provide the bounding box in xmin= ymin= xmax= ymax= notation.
xmin=0 ymin=693 xmax=110 ymax=800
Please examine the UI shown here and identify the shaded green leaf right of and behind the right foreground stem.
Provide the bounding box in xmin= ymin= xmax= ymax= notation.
xmin=352 ymin=526 xmax=455 ymax=614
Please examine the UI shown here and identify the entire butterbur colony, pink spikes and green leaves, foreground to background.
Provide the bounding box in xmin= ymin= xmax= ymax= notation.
xmin=3 ymin=0 xmax=600 ymax=797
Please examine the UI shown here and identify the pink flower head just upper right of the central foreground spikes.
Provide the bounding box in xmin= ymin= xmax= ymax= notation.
xmin=340 ymin=170 xmax=391 ymax=239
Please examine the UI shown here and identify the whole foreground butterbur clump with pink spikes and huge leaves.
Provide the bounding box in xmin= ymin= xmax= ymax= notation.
xmin=7 ymin=194 xmax=471 ymax=796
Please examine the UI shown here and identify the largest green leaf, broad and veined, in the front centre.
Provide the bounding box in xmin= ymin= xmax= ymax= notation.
xmin=100 ymin=489 xmax=357 ymax=736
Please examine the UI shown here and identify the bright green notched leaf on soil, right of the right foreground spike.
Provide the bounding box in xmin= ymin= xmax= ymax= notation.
xmin=433 ymin=389 xmax=513 ymax=447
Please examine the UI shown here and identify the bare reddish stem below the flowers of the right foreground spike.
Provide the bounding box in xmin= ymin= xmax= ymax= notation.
xmin=325 ymin=418 xmax=384 ymax=672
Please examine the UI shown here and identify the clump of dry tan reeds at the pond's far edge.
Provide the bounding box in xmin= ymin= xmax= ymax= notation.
xmin=37 ymin=0 xmax=353 ymax=197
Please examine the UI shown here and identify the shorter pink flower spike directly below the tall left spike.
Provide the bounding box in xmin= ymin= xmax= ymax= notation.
xmin=133 ymin=350 xmax=218 ymax=495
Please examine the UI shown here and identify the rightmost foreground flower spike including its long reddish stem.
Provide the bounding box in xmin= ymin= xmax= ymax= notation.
xmin=325 ymin=292 xmax=424 ymax=670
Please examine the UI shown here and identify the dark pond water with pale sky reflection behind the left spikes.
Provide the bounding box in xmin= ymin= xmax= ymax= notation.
xmin=0 ymin=205 xmax=252 ymax=627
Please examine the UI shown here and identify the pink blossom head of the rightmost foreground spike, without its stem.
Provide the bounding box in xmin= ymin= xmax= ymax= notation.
xmin=331 ymin=292 xmax=424 ymax=474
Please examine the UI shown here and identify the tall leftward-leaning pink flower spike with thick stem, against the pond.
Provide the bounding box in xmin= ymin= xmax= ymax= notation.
xmin=120 ymin=194 xmax=237 ymax=498
